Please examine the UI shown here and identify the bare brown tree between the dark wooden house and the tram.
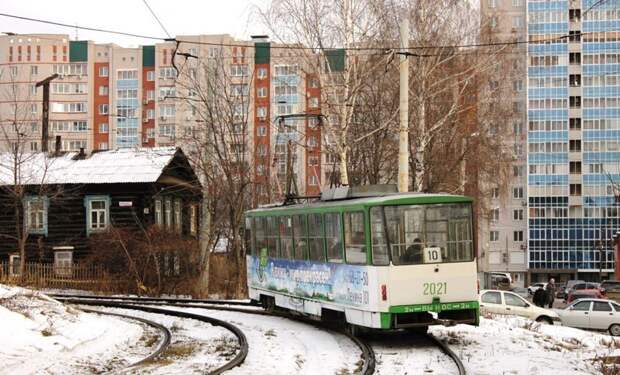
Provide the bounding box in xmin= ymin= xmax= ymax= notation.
xmin=171 ymin=42 xmax=253 ymax=296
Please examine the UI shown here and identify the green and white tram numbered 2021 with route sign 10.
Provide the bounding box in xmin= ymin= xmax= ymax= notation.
xmin=245 ymin=187 xmax=479 ymax=329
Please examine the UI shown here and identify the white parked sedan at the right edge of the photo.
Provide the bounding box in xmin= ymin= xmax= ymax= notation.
xmin=556 ymin=298 xmax=620 ymax=336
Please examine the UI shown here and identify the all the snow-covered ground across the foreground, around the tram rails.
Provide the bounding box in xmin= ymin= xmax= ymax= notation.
xmin=0 ymin=285 xmax=620 ymax=375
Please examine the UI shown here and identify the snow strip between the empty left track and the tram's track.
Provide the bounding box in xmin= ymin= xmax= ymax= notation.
xmin=172 ymin=308 xmax=362 ymax=375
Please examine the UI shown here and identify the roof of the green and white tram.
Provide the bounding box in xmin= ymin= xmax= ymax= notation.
xmin=247 ymin=193 xmax=473 ymax=214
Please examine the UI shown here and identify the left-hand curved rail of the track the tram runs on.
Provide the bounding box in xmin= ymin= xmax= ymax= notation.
xmin=56 ymin=296 xmax=376 ymax=375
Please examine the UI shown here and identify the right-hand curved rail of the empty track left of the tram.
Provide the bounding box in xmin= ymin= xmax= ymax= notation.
xmin=55 ymin=296 xmax=249 ymax=375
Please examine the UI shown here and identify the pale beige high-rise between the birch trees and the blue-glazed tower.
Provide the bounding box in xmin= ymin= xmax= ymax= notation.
xmin=478 ymin=0 xmax=527 ymax=286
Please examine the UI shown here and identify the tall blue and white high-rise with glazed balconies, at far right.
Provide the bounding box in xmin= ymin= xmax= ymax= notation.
xmin=527 ymin=0 xmax=620 ymax=280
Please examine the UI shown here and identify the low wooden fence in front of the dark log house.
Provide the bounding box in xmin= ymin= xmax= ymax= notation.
xmin=0 ymin=262 xmax=118 ymax=290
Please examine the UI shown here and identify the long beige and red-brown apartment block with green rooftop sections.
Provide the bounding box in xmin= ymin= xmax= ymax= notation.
xmin=0 ymin=34 xmax=327 ymax=201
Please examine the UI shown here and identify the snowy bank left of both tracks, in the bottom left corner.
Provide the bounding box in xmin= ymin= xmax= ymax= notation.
xmin=0 ymin=284 xmax=153 ymax=374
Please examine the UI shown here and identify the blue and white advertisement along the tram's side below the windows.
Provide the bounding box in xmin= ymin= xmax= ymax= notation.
xmin=248 ymin=256 xmax=376 ymax=307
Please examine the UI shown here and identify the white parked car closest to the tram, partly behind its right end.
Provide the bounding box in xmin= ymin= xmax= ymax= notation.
xmin=478 ymin=290 xmax=560 ymax=324
